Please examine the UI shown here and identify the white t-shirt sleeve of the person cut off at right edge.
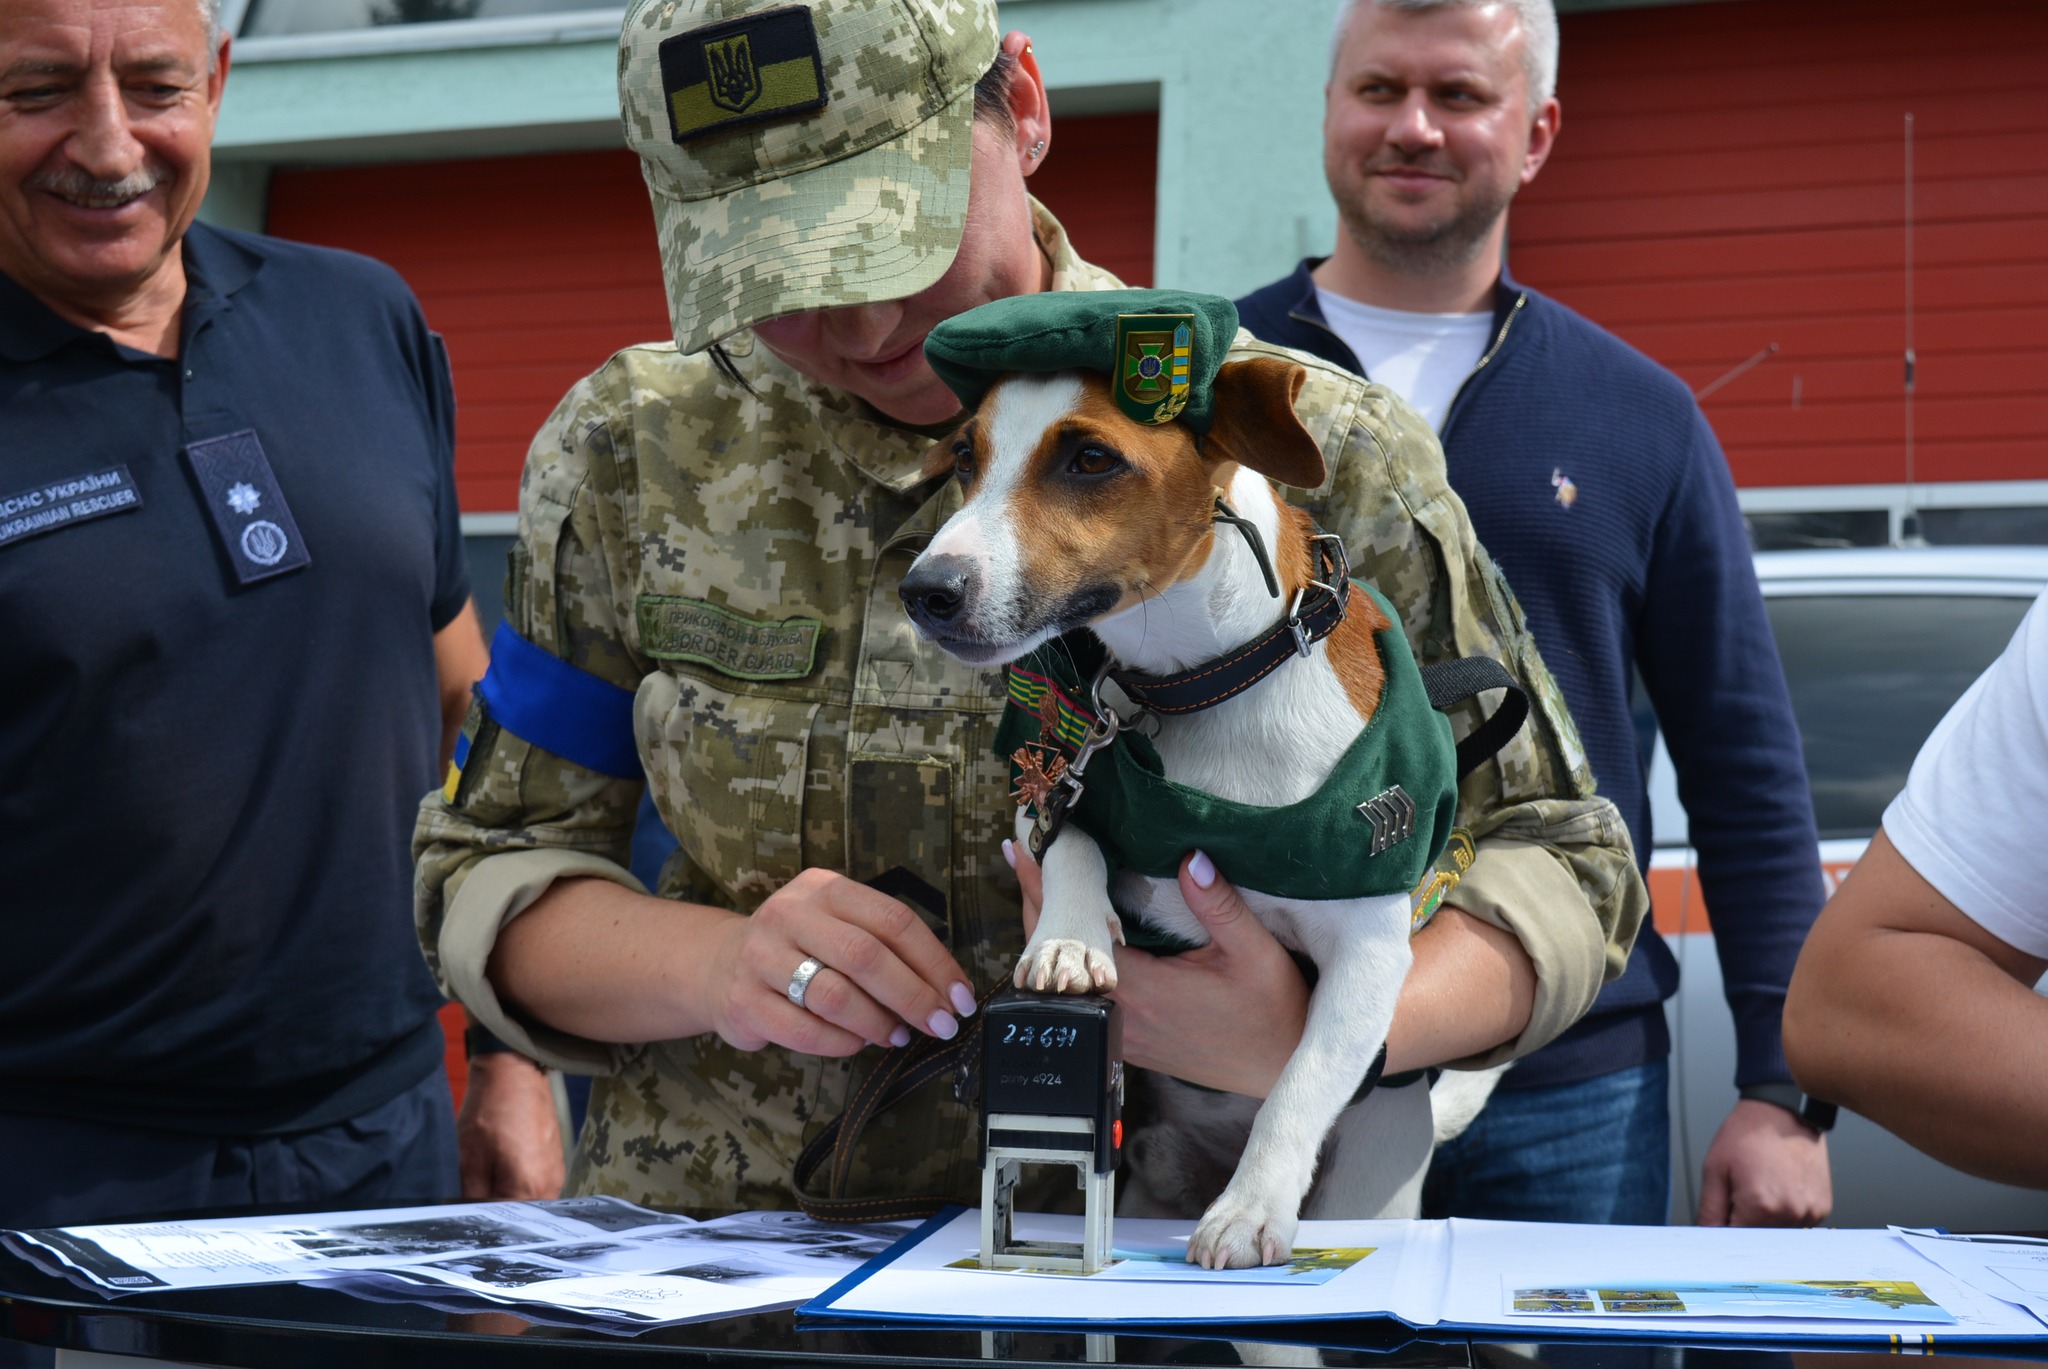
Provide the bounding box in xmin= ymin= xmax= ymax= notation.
xmin=1884 ymin=594 xmax=2048 ymax=957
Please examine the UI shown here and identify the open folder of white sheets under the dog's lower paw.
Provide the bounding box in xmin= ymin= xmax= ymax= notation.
xmin=801 ymin=1211 xmax=2048 ymax=1344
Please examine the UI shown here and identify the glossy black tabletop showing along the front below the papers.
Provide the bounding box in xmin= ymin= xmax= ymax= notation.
xmin=0 ymin=1252 xmax=2048 ymax=1369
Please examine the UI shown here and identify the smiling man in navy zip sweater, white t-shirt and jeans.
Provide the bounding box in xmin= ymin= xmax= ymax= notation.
xmin=1237 ymin=0 xmax=1831 ymax=1226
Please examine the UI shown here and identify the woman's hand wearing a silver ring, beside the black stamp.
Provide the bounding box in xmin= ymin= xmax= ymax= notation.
xmin=711 ymin=869 xmax=975 ymax=1055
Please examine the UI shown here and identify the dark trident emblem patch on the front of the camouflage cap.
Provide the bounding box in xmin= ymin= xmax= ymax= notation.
xmin=659 ymin=4 xmax=831 ymax=143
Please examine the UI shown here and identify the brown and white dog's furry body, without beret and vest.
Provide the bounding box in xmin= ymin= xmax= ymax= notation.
xmin=901 ymin=301 xmax=1456 ymax=1269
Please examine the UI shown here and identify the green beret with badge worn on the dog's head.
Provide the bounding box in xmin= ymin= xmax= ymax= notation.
xmin=924 ymin=289 xmax=1237 ymax=432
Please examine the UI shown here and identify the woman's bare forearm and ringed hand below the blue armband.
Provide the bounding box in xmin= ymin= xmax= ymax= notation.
xmin=489 ymin=869 xmax=975 ymax=1055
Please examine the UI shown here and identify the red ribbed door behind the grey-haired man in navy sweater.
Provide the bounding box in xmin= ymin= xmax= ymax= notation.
xmin=1509 ymin=0 xmax=2048 ymax=486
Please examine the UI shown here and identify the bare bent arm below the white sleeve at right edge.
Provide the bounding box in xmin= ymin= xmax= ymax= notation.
xmin=1786 ymin=828 xmax=2048 ymax=1189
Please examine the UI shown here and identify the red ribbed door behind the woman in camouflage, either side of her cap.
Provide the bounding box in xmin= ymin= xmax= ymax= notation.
xmin=268 ymin=113 xmax=1159 ymax=512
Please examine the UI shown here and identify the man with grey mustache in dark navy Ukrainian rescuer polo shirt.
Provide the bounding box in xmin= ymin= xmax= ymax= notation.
xmin=0 ymin=0 xmax=561 ymax=1254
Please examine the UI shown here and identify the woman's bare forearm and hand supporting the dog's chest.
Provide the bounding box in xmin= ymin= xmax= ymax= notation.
xmin=1006 ymin=846 xmax=1536 ymax=1098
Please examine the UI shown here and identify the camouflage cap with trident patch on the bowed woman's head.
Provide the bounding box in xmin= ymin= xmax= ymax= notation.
xmin=618 ymin=0 xmax=997 ymax=352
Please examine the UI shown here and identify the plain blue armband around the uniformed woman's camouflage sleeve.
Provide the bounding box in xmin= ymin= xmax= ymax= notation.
xmin=475 ymin=623 xmax=641 ymax=779
